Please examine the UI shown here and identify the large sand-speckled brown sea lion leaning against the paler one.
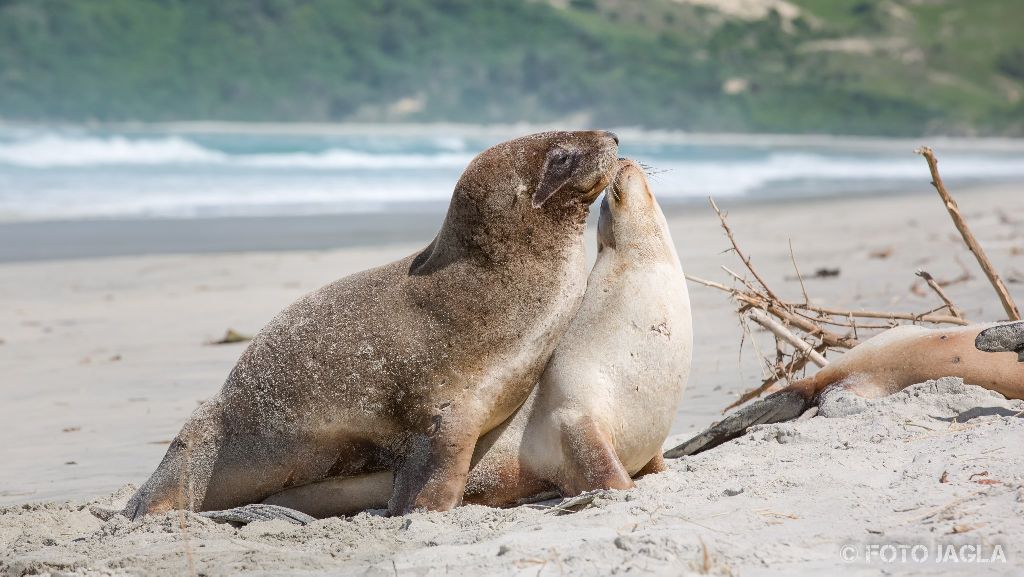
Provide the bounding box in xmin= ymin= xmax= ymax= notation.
xmin=119 ymin=131 xmax=617 ymax=518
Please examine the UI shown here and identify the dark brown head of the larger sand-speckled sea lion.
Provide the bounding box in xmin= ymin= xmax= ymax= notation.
xmin=423 ymin=130 xmax=618 ymax=260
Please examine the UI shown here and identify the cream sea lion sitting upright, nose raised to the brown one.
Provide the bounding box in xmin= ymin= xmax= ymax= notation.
xmin=265 ymin=161 xmax=693 ymax=518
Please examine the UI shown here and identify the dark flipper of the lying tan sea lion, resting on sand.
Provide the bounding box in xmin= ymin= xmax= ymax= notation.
xmin=665 ymin=390 xmax=810 ymax=459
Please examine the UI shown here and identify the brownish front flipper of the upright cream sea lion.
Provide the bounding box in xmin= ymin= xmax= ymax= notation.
xmin=557 ymin=417 xmax=633 ymax=497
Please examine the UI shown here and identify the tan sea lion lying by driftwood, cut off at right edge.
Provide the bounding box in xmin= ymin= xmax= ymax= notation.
xmin=665 ymin=322 xmax=1024 ymax=458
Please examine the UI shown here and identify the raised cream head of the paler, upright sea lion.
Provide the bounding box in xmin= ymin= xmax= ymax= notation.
xmin=597 ymin=159 xmax=679 ymax=262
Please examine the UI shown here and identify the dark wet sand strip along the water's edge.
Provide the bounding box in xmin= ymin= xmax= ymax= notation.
xmin=0 ymin=181 xmax=1024 ymax=263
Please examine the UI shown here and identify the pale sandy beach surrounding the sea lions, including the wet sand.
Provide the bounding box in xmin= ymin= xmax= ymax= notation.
xmin=0 ymin=184 xmax=1024 ymax=575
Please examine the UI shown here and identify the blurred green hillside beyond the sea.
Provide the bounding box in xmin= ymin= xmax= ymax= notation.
xmin=0 ymin=0 xmax=1024 ymax=135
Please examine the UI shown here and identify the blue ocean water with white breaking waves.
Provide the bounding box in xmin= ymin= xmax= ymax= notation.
xmin=0 ymin=127 xmax=1024 ymax=221
